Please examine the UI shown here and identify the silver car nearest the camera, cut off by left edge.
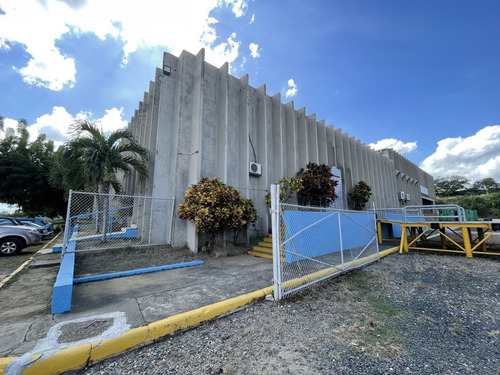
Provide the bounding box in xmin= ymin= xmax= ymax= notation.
xmin=0 ymin=225 xmax=42 ymax=255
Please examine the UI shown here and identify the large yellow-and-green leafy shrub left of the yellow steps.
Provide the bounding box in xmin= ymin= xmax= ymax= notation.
xmin=178 ymin=177 xmax=257 ymax=249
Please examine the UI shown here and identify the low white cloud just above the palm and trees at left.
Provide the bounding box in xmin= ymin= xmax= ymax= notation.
xmin=4 ymin=106 xmax=128 ymax=147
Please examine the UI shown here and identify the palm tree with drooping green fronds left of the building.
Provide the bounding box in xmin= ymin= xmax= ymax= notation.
xmin=63 ymin=121 xmax=149 ymax=241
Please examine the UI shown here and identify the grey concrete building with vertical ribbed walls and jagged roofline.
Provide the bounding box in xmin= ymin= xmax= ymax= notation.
xmin=124 ymin=49 xmax=435 ymax=251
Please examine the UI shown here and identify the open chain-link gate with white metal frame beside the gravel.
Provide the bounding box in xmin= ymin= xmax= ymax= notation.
xmin=271 ymin=185 xmax=379 ymax=300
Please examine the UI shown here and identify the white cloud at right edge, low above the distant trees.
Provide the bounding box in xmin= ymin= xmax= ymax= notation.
xmin=421 ymin=125 xmax=500 ymax=181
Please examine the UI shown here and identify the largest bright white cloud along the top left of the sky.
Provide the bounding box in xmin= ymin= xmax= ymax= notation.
xmin=0 ymin=0 xmax=248 ymax=90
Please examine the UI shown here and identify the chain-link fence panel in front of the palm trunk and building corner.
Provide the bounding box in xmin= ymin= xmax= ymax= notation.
xmin=63 ymin=191 xmax=175 ymax=252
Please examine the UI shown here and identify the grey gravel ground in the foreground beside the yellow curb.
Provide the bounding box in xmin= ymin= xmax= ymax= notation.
xmin=71 ymin=252 xmax=500 ymax=375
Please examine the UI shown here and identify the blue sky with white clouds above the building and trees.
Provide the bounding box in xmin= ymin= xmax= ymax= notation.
xmin=0 ymin=0 xmax=500 ymax=185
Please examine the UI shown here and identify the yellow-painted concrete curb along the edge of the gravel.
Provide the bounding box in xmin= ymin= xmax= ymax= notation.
xmin=0 ymin=247 xmax=399 ymax=375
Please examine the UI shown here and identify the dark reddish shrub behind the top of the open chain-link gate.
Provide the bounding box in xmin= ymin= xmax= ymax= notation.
xmin=297 ymin=163 xmax=338 ymax=207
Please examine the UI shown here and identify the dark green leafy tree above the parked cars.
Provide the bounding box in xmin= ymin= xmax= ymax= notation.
xmin=0 ymin=119 xmax=66 ymax=217
